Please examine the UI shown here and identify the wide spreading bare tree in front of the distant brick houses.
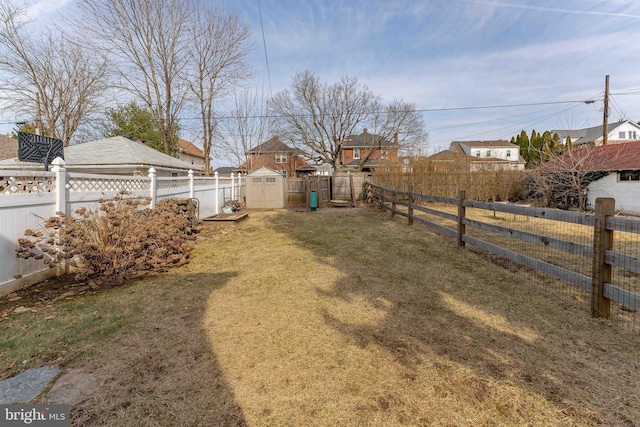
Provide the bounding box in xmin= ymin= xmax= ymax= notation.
xmin=271 ymin=71 xmax=424 ymax=169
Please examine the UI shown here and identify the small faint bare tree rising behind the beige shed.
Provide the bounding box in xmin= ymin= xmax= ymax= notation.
xmin=220 ymin=90 xmax=269 ymax=165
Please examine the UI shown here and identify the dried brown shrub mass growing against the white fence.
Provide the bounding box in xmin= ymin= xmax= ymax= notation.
xmin=16 ymin=192 xmax=199 ymax=283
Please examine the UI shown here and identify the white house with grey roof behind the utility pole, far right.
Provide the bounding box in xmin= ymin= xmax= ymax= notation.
xmin=551 ymin=120 xmax=640 ymax=147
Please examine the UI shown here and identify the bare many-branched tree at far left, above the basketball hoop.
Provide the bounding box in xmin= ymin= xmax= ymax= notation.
xmin=0 ymin=0 xmax=107 ymax=146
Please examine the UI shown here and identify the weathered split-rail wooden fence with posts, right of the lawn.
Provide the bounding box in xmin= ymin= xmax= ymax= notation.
xmin=363 ymin=183 xmax=640 ymax=328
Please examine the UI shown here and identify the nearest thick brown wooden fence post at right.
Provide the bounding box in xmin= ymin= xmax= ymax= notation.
xmin=591 ymin=198 xmax=615 ymax=319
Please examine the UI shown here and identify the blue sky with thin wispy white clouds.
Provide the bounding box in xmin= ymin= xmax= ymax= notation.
xmin=3 ymin=0 xmax=640 ymax=159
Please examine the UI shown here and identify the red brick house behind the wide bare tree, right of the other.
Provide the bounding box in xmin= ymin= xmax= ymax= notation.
xmin=340 ymin=129 xmax=398 ymax=172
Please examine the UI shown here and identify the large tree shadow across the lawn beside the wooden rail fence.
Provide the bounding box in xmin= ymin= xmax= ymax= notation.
xmin=278 ymin=211 xmax=640 ymax=425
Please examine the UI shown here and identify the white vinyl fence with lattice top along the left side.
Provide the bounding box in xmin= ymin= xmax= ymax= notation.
xmin=0 ymin=158 xmax=245 ymax=295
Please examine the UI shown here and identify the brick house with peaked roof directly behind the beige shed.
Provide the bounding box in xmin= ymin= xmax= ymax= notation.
xmin=240 ymin=135 xmax=309 ymax=177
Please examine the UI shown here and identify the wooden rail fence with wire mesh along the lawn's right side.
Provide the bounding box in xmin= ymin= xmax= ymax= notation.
xmin=363 ymin=183 xmax=640 ymax=330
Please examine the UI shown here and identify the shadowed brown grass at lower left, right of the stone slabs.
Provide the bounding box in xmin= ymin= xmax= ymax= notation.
xmin=71 ymin=273 xmax=246 ymax=426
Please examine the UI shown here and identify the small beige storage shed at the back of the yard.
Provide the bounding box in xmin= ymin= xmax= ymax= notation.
xmin=245 ymin=167 xmax=287 ymax=209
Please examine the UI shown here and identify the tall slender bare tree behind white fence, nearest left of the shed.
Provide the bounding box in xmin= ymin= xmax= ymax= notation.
xmin=185 ymin=4 xmax=251 ymax=175
